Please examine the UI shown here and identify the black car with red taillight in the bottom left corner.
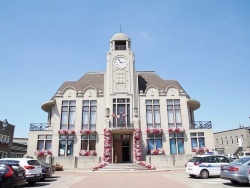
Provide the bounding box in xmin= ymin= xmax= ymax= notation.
xmin=0 ymin=164 xmax=26 ymax=188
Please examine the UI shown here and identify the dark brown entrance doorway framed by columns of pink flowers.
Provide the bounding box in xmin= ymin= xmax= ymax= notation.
xmin=113 ymin=134 xmax=131 ymax=163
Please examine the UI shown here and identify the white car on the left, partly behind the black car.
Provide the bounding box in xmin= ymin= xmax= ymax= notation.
xmin=0 ymin=158 xmax=42 ymax=184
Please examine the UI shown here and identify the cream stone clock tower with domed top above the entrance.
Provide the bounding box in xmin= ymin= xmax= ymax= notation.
xmin=104 ymin=33 xmax=138 ymax=124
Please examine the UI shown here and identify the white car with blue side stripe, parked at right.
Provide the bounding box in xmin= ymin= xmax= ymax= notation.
xmin=186 ymin=155 xmax=232 ymax=179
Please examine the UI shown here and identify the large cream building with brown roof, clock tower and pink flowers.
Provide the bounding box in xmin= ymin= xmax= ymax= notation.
xmin=27 ymin=33 xmax=214 ymax=169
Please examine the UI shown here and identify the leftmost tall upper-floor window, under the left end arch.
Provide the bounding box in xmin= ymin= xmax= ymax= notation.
xmin=61 ymin=101 xmax=76 ymax=130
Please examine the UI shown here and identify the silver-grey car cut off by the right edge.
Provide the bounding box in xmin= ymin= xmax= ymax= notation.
xmin=220 ymin=157 xmax=250 ymax=184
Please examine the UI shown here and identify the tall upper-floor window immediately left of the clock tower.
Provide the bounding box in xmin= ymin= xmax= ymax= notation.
xmin=82 ymin=100 xmax=96 ymax=130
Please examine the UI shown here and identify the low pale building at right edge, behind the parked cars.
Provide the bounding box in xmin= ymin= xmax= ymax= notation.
xmin=214 ymin=126 xmax=250 ymax=155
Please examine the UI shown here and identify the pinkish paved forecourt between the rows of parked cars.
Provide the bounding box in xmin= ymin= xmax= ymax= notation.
xmin=21 ymin=169 xmax=249 ymax=188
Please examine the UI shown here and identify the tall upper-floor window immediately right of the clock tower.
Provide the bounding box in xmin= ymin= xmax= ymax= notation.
xmin=146 ymin=100 xmax=161 ymax=129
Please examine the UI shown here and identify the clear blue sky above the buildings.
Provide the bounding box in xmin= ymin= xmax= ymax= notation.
xmin=0 ymin=0 xmax=250 ymax=137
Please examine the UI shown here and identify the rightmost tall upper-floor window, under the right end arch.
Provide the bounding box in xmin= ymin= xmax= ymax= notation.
xmin=167 ymin=99 xmax=182 ymax=128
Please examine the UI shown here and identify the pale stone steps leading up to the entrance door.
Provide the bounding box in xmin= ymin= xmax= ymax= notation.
xmin=98 ymin=163 xmax=148 ymax=171
